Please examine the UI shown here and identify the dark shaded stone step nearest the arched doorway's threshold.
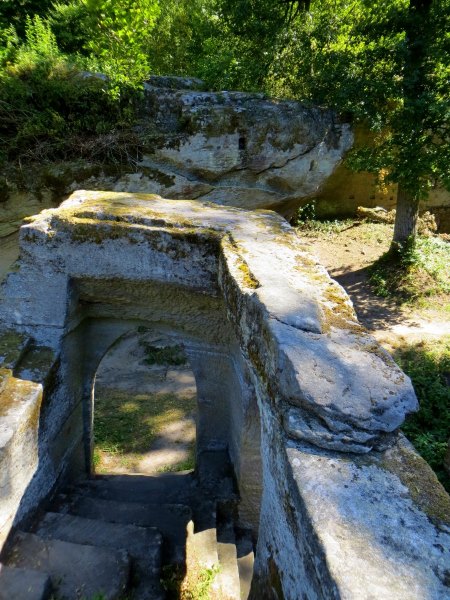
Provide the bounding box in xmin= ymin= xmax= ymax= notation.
xmin=78 ymin=473 xmax=197 ymax=505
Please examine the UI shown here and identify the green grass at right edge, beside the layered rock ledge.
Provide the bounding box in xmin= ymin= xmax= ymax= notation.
xmin=394 ymin=336 xmax=450 ymax=493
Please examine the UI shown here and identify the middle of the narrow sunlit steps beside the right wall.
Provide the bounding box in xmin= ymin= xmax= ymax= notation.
xmin=217 ymin=520 xmax=241 ymax=600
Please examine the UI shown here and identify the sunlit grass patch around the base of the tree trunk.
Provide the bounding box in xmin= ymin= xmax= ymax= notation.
xmin=369 ymin=237 xmax=450 ymax=302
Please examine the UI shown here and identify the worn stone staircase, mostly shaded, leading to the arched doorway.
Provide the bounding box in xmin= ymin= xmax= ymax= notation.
xmin=0 ymin=451 xmax=253 ymax=600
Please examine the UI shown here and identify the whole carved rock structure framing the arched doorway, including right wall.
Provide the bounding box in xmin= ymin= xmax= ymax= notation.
xmin=0 ymin=192 xmax=450 ymax=600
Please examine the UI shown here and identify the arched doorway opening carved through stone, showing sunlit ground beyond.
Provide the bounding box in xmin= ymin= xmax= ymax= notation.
xmin=92 ymin=329 xmax=197 ymax=475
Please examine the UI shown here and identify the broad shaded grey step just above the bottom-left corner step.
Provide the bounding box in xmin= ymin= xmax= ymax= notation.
xmin=6 ymin=532 xmax=129 ymax=600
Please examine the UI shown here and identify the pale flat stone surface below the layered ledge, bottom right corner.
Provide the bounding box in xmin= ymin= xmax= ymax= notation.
xmin=288 ymin=440 xmax=450 ymax=600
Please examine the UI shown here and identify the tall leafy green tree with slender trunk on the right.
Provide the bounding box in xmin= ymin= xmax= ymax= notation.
xmin=267 ymin=0 xmax=450 ymax=242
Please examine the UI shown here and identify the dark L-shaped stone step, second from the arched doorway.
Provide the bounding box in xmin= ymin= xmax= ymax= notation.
xmin=60 ymin=495 xmax=191 ymax=563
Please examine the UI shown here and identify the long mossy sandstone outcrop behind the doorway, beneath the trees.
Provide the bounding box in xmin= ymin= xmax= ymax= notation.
xmin=0 ymin=77 xmax=353 ymax=236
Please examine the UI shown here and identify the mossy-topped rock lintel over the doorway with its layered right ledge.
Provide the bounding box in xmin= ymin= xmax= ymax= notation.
xmin=0 ymin=192 xmax=417 ymax=453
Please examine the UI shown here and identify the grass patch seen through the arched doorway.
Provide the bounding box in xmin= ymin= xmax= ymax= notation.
xmin=93 ymin=389 xmax=197 ymax=472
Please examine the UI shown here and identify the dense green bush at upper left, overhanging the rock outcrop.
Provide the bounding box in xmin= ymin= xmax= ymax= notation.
xmin=0 ymin=16 xmax=141 ymax=162
